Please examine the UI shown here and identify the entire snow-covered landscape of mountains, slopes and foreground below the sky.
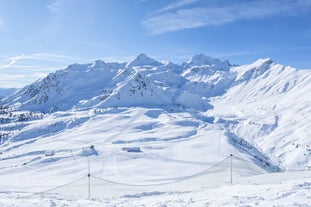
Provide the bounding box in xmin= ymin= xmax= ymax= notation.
xmin=0 ymin=54 xmax=311 ymax=206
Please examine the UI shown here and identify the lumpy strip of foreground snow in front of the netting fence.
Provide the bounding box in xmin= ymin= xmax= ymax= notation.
xmin=0 ymin=171 xmax=311 ymax=207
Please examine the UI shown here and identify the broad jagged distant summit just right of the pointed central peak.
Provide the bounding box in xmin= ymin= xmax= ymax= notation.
xmin=184 ymin=54 xmax=230 ymax=70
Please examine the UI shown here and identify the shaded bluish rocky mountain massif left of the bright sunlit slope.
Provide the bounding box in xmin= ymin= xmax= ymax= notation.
xmin=6 ymin=54 xmax=229 ymax=112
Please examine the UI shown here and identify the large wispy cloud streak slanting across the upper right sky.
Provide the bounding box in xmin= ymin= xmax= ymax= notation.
xmin=142 ymin=0 xmax=311 ymax=34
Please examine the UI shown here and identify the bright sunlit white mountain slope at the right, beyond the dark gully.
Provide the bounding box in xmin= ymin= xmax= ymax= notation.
xmin=208 ymin=59 xmax=311 ymax=169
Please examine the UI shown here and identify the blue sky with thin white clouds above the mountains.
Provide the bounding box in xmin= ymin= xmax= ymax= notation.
xmin=0 ymin=0 xmax=311 ymax=87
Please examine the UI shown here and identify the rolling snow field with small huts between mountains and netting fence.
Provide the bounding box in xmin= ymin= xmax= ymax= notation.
xmin=0 ymin=108 xmax=272 ymax=201
